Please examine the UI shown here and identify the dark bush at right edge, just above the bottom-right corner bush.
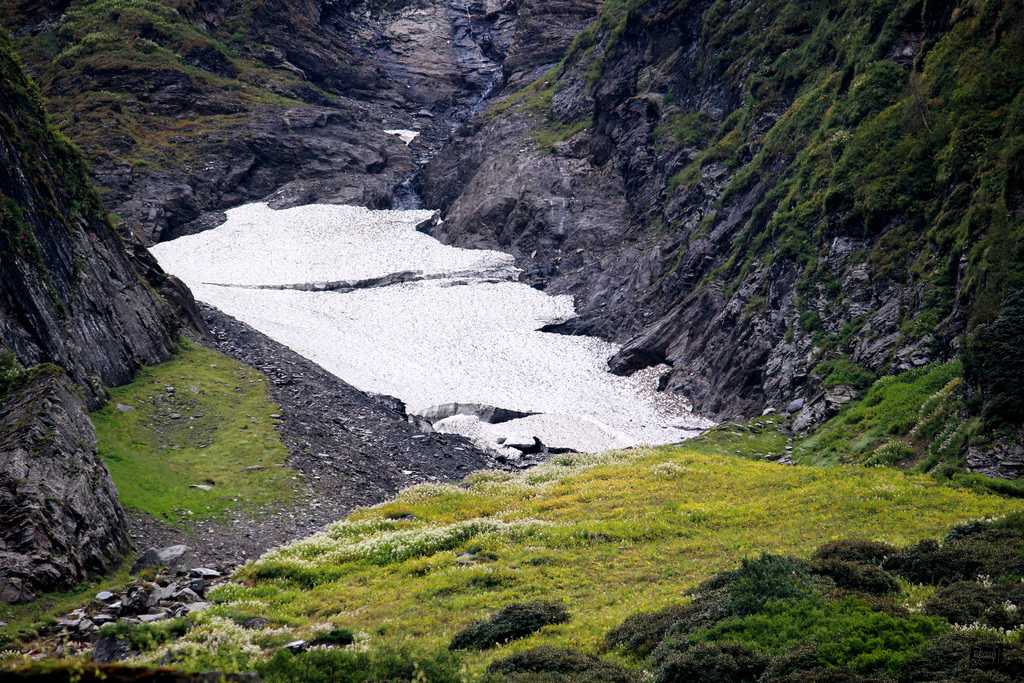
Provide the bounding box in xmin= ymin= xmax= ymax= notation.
xmin=925 ymin=581 xmax=1024 ymax=629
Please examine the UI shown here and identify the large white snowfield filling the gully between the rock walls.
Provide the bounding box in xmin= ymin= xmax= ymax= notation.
xmin=153 ymin=204 xmax=709 ymax=455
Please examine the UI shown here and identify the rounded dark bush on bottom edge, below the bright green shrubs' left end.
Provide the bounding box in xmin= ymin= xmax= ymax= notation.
xmin=654 ymin=643 xmax=768 ymax=683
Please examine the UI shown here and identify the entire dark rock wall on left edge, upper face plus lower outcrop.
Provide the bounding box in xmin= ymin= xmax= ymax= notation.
xmin=0 ymin=33 xmax=199 ymax=601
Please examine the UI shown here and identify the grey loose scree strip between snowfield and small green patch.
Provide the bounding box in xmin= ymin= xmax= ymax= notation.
xmin=121 ymin=304 xmax=501 ymax=568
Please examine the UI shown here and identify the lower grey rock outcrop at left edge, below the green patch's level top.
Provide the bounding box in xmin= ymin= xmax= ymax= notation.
xmin=0 ymin=369 xmax=128 ymax=602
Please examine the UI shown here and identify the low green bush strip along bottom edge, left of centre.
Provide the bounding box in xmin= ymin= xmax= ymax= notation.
xmin=258 ymin=649 xmax=463 ymax=683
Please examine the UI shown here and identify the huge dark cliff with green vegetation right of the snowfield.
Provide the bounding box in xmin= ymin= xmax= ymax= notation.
xmin=423 ymin=0 xmax=1024 ymax=440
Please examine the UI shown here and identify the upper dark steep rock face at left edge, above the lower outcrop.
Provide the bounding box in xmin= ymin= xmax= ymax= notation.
xmin=0 ymin=30 xmax=191 ymax=404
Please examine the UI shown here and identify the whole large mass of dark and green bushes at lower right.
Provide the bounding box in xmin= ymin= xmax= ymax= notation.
xmin=605 ymin=514 xmax=1024 ymax=683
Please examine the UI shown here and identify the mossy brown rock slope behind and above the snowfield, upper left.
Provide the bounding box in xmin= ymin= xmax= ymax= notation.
xmin=0 ymin=0 xmax=544 ymax=245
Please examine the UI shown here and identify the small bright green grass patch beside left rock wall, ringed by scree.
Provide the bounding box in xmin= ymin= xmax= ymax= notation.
xmin=92 ymin=343 xmax=297 ymax=524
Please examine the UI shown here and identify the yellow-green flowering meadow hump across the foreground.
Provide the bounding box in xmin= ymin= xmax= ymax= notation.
xmin=114 ymin=446 xmax=1024 ymax=673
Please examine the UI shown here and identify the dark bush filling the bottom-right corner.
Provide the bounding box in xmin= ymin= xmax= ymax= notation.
xmin=899 ymin=632 xmax=1024 ymax=683
